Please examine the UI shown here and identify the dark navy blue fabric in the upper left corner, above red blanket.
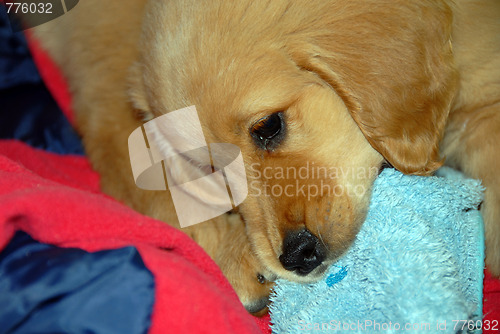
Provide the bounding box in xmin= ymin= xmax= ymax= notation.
xmin=0 ymin=4 xmax=83 ymax=154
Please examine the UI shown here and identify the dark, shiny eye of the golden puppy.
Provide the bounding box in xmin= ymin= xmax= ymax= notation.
xmin=250 ymin=112 xmax=285 ymax=151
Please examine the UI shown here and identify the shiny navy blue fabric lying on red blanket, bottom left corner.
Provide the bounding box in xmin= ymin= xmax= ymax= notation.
xmin=0 ymin=232 xmax=154 ymax=334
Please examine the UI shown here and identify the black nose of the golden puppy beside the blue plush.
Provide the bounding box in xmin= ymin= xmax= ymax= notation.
xmin=280 ymin=229 xmax=326 ymax=276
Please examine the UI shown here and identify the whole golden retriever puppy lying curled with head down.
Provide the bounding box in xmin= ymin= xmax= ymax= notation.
xmin=36 ymin=0 xmax=500 ymax=312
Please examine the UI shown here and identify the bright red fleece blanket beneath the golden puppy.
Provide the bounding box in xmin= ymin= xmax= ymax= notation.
xmin=0 ymin=32 xmax=500 ymax=333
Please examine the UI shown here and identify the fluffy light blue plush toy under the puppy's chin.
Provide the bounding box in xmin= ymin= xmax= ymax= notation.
xmin=270 ymin=169 xmax=484 ymax=334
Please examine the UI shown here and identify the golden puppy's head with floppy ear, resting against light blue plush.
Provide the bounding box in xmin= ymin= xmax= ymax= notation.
xmin=131 ymin=0 xmax=455 ymax=281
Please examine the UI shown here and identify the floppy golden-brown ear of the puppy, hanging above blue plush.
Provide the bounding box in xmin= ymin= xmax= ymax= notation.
xmin=289 ymin=0 xmax=456 ymax=175
